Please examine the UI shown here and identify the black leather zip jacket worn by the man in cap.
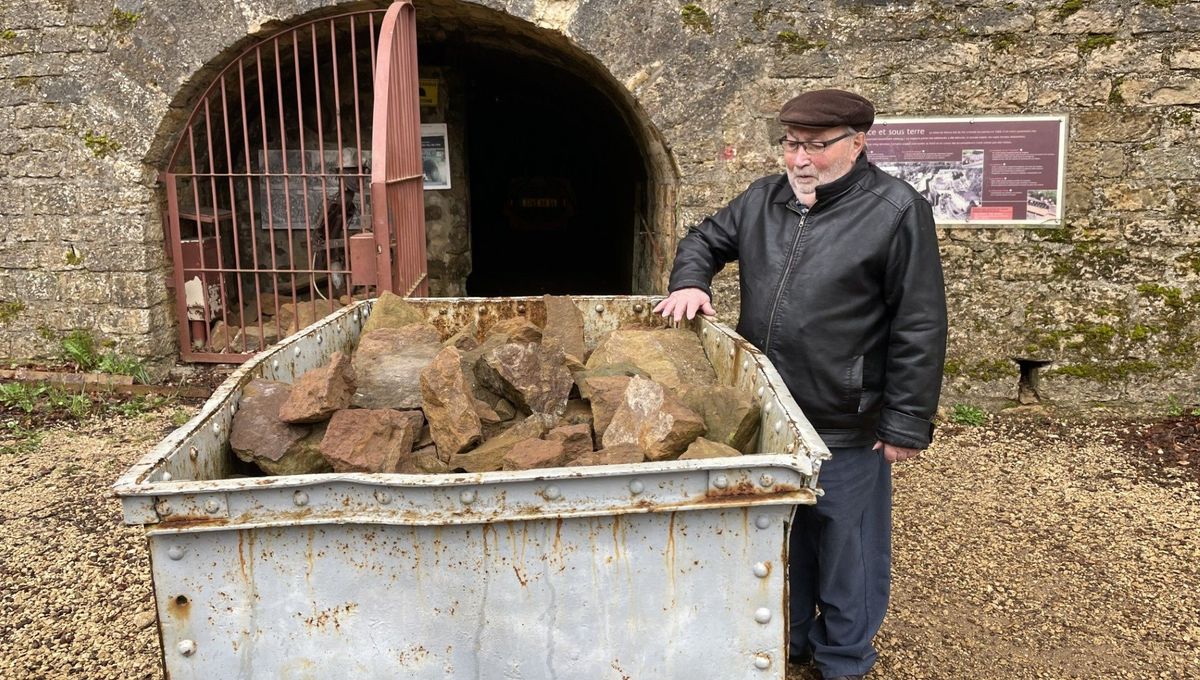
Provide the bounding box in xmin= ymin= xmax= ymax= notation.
xmin=670 ymin=152 xmax=946 ymax=449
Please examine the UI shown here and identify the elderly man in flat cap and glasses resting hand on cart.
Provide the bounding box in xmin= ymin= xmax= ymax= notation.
xmin=655 ymin=90 xmax=946 ymax=679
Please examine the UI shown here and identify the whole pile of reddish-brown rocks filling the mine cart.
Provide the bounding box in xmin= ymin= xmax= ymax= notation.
xmin=229 ymin=294 xmax=760 ymax=475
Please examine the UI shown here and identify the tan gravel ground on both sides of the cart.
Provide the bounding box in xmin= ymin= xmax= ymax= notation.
xmin=0 ymin=405 xmax=1200 ymax=680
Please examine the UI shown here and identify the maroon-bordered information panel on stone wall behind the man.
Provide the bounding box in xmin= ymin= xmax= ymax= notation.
xmin=866 ymin=115 xmax=1067 ymax=227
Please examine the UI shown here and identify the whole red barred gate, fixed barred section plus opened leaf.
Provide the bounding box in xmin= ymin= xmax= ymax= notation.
xmin=162 ymin=0 xmax=427 ymax=362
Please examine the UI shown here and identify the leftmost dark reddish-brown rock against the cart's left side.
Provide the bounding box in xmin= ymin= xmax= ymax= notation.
xmin=229 ymin=379 xmax=330 ymax=475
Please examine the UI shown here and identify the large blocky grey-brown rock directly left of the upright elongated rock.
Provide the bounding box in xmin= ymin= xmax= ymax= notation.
xmin=350 ymin=324 xmax=442 ymax=409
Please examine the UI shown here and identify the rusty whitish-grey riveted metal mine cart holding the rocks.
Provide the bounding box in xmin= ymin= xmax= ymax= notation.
xmin=115 ymin=296 xmax=829 ymax=680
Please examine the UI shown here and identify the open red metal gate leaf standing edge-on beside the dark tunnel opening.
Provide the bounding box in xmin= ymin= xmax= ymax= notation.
xmin=371 ymin=0 xmax=428 ymax=296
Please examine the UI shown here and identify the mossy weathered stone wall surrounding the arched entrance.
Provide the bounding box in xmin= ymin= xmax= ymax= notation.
xmin=0 ymin=0 xmax=1200 ymax=403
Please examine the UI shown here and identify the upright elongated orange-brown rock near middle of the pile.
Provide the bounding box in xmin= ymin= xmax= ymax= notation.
xmin=421 ymin=347 xmax=482 ymax=461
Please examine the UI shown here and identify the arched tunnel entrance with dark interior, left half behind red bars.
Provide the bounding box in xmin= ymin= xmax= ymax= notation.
xmin=152 ymin=0 xmax=678 ymax=361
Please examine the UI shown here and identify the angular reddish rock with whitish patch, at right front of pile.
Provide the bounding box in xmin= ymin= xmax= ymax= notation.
xmin=602 ymin=377 xmax=704 ymax=461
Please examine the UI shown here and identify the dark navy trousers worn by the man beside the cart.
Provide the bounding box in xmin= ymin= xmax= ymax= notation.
xmin=788 ymin=446 xmax=892 ymax=678
